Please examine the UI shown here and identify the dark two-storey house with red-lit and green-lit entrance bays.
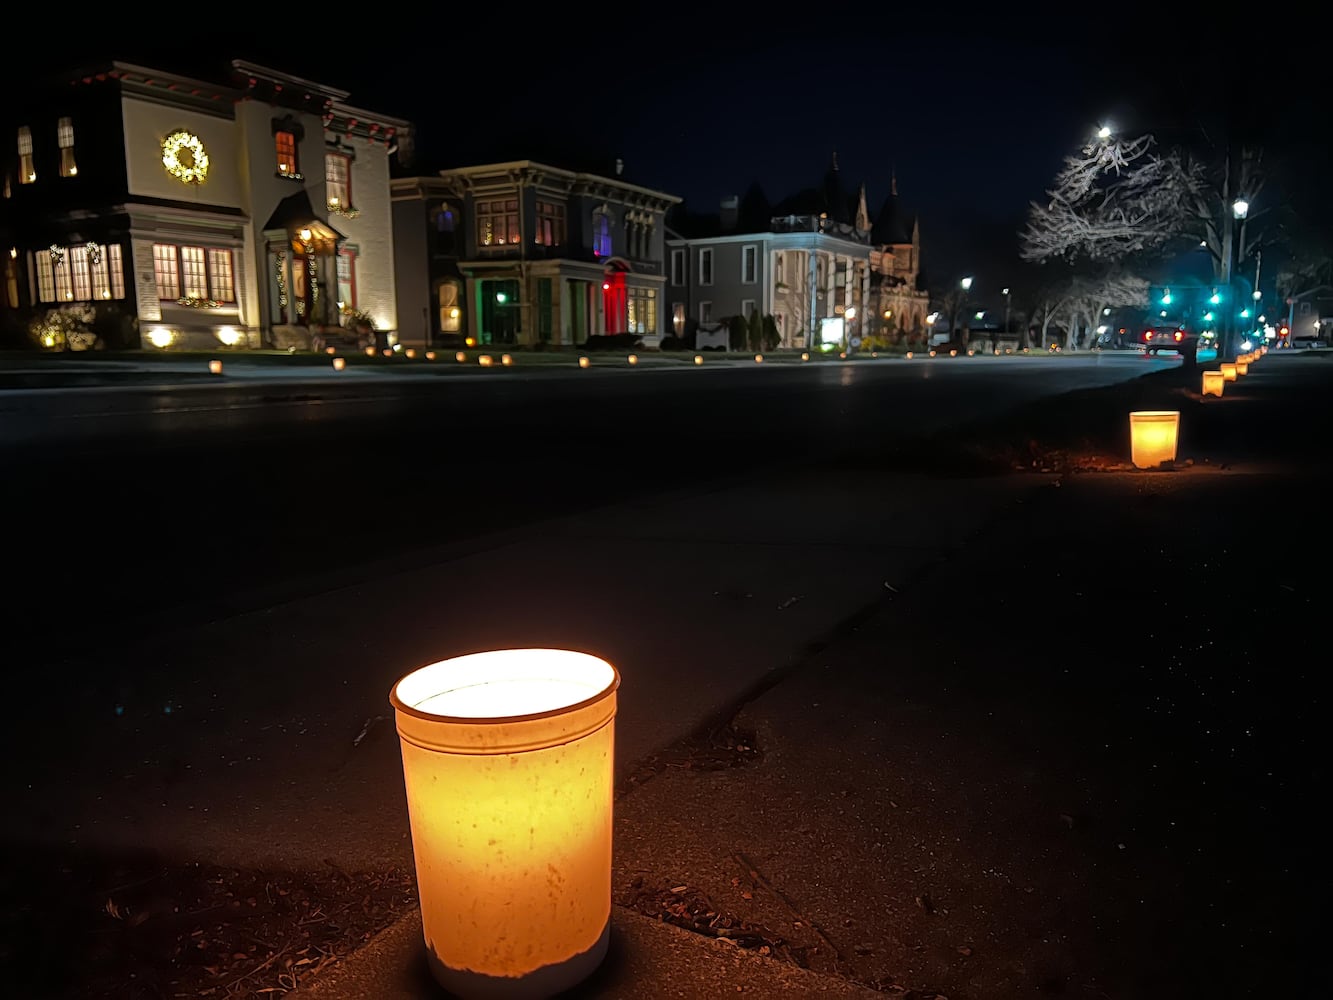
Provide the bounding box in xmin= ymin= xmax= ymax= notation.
xmin=392 ymin=160 xmax=680 ymax=347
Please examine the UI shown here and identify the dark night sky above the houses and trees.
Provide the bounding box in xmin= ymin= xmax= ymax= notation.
xmin=3 ymin=3 xmax=1329 ymax=300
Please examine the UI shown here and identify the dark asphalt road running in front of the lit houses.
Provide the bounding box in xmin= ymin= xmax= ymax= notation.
xmin=0 ymin=355 xmax=1176 ymax=651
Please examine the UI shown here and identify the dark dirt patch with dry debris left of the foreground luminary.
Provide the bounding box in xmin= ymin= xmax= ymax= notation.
xmin=0 ymin=848 xmax=417 ymax=1000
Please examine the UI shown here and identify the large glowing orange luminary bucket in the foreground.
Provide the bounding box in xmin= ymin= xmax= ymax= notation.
xmin=389 ymin=649 xmax=620 ymax=997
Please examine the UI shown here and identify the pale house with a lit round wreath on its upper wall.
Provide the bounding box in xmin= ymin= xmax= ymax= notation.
xmin=0 ymin=60 xmax=411 ymax=349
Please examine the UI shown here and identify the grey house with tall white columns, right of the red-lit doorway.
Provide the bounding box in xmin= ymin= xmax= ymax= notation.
xmin=667 ymin=156 xmax=884 ymax=349
